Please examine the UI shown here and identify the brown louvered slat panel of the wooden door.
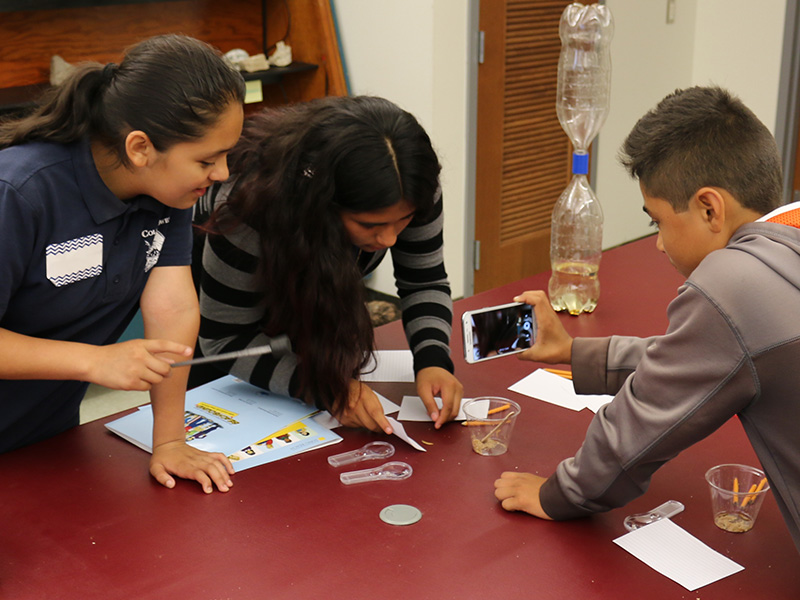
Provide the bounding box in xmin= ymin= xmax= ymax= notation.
xmin=500 ymin=0 xmax=570 ymax=244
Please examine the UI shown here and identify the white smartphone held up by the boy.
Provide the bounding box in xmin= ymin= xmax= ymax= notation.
xmin=461 ymin=302 xmax=536 ymax=364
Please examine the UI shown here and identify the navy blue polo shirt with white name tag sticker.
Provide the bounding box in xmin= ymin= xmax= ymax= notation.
xmin=0 ymin=140 xmax=192 ymax=452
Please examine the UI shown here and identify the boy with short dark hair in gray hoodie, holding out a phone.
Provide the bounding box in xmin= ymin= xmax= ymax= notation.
xmin=495 ymin=87 xmax=800 ymax=550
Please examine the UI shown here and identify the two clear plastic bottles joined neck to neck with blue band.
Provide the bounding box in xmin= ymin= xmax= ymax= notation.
xmin=548 ymin=2 xmax=614 ymax=315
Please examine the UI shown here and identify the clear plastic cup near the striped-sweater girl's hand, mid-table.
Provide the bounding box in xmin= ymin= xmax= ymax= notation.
xmin=462 ymin=396 xmax=520 ymax=456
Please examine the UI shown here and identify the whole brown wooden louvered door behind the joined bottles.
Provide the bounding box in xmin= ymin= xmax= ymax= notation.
xmin=475 ymin=0 xmax=571 ymax=293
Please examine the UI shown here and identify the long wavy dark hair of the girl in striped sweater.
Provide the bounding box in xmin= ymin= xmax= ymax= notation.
xmin=210 ymin=96 xmax=440 ymax=414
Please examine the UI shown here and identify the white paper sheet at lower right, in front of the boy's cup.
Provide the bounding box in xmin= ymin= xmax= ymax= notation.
xmin=614 ymin=519 xmax=744 ymax=592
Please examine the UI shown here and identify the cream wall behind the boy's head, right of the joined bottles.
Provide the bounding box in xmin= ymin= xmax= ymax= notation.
xmin=596 ymin=0 xmax=786 ymax=248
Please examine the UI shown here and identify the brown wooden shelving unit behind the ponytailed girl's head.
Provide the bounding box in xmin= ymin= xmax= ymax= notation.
xmin=0 ymin=0 xmax=347 ymax=111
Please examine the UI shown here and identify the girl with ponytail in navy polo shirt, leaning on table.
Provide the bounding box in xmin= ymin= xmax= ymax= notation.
xmin=0 ymin=35 xmax=244 ymax=493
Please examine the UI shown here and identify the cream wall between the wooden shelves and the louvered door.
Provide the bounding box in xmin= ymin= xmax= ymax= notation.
xmin=333 ymin=0 xmax=471 ymax=297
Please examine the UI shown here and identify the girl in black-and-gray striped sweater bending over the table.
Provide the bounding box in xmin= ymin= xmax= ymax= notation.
xmin=200 ymin=97 xmax=462 ymax=433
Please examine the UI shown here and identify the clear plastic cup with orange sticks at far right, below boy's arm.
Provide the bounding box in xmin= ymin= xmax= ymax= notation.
xmin=706 ymin=464 xmax=769 ymax=533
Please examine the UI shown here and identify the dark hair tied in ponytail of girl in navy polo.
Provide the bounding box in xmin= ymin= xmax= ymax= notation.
xmin=0 ymin=34 xmax=244 ymax=158
